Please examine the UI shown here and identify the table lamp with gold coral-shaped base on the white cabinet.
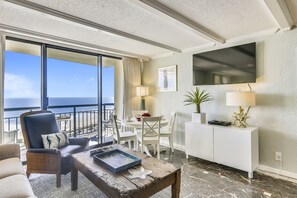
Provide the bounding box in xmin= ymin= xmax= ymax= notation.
xmin=226 ymin=91 xmax=256 ymax=128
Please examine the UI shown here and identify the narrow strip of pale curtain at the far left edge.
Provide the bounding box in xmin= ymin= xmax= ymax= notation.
xmin=0 ymin=34 xmax=5 ymax=144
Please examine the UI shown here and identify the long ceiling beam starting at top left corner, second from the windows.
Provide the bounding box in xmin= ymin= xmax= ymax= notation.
xmin=4 ymin=0 xmax=181 ymax=53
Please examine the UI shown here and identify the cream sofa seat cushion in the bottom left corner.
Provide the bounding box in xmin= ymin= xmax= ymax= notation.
xmin=0 ymin=174 xmax=35 ymax=198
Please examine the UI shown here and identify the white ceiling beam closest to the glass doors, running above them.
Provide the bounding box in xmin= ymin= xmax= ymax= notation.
xmin=0 ymin=23 xmax=150 ymax=60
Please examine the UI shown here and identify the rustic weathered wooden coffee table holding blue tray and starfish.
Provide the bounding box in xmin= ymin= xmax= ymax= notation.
xmin=71 ymin=145 xmax=181 ymax=198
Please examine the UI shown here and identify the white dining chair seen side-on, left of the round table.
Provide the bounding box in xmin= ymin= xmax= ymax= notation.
xmin=112 ymin=115 xmax=137 ymax=149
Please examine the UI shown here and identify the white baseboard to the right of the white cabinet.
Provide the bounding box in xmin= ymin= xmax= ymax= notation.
xmin=257 ymin=165 xmax=297 ymax=183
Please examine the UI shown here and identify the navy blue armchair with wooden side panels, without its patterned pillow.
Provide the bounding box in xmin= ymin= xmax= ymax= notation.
xmin=20 ymin=111 xmax=89 ymax=187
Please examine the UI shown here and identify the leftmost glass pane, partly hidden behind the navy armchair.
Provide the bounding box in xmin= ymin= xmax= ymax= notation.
xmin=4 ymin=40 xmax=41 ymax=144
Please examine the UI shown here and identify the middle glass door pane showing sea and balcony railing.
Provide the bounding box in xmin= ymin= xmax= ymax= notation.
xmin=46 ymin=48 xmax=100 ymax=141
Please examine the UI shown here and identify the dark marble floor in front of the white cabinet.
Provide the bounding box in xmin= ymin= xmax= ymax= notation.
xmin=157 ymin=148 xmax=297 ymax=198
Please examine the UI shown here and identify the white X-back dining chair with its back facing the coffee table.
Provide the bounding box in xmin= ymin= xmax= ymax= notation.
xmin=138 ymin=116 xmax=161 ymax=159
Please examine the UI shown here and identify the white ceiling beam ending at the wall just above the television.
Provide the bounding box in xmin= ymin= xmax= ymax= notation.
xmin=129 ymin=0 xmax=225 ymax=43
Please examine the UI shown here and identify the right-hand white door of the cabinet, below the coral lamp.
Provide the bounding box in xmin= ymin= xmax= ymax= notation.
xmin=214 ymin=127 xmax=251 ymax=171
